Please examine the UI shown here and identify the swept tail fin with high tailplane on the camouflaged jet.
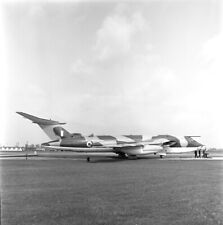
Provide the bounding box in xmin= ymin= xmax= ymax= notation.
xmin=16 ymin=112 xmax=71 ymax=140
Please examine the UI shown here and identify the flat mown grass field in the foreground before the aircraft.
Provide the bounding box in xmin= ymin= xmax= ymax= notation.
xmin=1 ymin=158 xmax=223 ymax=225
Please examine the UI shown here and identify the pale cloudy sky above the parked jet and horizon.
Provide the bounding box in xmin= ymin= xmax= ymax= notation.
xmin=0 ymin=0 xmax=223 ymax=147
